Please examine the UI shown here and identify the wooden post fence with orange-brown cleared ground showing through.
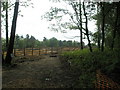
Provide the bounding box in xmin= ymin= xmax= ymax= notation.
xmin=3 ymin=47 xmax=79 ymax=56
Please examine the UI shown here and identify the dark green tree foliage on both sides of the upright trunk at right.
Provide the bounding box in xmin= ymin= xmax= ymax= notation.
xmin=92 ymin=2 xmax=120 ymax=49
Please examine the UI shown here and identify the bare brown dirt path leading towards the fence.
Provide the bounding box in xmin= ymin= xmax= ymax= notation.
xmin=3 ymin=55 xmax=72 ymax=88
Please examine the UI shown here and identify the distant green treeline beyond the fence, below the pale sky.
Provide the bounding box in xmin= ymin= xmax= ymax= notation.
xmin=2 ymin=34 xmax=81 ymax=51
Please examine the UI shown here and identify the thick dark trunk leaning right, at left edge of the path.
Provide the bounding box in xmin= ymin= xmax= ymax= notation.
xmin=5 ymin=0 xmax=19 ymax=64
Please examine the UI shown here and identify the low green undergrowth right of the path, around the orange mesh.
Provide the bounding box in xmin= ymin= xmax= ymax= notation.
xmin=62 ymin=49 xmax=120 ymax=88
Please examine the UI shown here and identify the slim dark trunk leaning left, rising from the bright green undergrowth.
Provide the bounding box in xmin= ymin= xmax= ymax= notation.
xmin=83 ymin=2 xmax=92 ymax=52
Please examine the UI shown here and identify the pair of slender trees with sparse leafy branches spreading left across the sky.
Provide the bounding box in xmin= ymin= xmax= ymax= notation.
xmin=44 ymin=0 xmax=95 ymax=52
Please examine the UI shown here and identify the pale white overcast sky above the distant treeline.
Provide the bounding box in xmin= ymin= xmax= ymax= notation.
xmin=2 ymin=0 xmax=95 ymax=43
